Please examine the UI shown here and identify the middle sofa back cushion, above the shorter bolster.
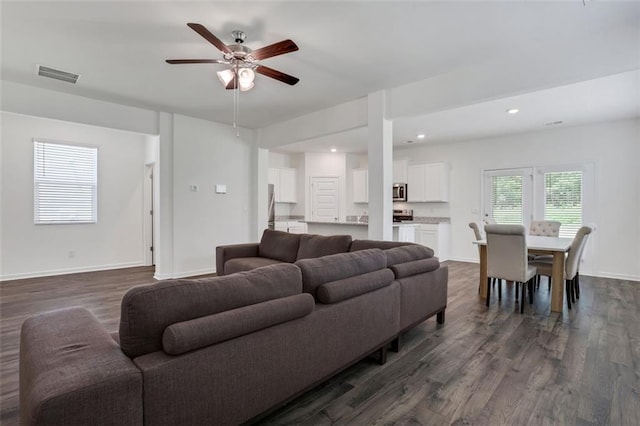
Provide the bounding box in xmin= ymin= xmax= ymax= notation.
xmin=296 ymin=249 xmax=387 ymax=301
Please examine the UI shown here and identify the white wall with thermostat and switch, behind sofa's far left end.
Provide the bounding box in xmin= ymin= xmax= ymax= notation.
xmin=172 ymin=115 xmax=258 ymax=277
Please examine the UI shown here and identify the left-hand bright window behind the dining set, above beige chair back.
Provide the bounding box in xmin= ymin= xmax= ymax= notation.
xmin=491 ymin=176 xmax=523 ymax=225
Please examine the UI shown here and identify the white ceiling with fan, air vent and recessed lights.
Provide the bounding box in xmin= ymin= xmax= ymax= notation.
xmin=0 ymin=0 xmax=640 ymax=152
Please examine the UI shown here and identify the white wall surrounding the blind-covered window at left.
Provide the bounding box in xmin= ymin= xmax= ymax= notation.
xmin=0 ymin=112 xmax=148 ymax=280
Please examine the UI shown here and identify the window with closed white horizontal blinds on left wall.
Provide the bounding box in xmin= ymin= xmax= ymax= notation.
xmin=33 ymin=140 xmax=98 ymax=224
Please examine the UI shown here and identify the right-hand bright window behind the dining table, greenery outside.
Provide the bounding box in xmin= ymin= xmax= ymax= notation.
xmin=544 ymin=170 xmax=582 ymax=238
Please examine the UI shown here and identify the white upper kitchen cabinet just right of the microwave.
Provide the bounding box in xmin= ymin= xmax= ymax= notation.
xmin=407 ymin=163 xmax=449 ymax=202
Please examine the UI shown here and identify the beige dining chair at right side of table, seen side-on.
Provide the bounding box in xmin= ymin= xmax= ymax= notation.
xmin=529 ymin=226 xmax=593 ymax=309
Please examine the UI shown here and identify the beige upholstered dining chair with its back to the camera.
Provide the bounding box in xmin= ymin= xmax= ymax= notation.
xmin=484 ymin=225 xmax=536 ymax=313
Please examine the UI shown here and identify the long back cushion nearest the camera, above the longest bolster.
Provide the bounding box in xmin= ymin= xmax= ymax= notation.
xmin=120 ymin=263 xmax=302 ymax=358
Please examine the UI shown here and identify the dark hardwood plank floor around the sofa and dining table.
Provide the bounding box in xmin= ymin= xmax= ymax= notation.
xmin=0 ymin=262 xmax=640 ymax=425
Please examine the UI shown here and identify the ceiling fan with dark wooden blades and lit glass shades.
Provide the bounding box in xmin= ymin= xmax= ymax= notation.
xmin=167 ymin=23 xmax=300 ymax=92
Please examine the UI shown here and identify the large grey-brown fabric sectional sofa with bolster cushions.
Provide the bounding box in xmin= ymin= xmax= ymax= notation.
xmin=20 ymin=230 xmax=448 ymax=425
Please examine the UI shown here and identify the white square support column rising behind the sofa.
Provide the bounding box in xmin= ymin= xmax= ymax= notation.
xmin=368 ymin=90 xmax=393 ymax=241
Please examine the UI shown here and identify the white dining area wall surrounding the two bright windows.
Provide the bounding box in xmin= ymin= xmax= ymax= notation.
xmin=394 ymin=119 xmax=640 ymax=280
